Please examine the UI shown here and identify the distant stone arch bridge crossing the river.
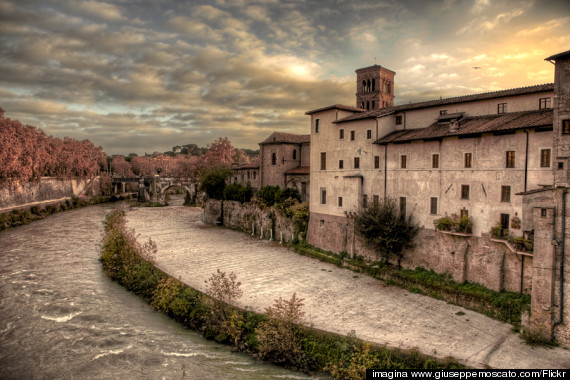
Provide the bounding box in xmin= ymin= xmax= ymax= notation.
xmin=112 ymin=176 xmax=198 ymax=203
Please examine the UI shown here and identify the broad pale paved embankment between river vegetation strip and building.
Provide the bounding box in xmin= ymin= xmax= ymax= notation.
xmin=127 ymin=207 xmax=570 ymax=368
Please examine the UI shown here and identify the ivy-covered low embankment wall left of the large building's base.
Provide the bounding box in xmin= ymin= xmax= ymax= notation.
xmin=204 ymin=200 xmax=295 ymax=243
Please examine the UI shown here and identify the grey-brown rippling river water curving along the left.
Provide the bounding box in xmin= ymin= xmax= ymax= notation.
xmin=0 ymin=199 xmax=307 ymax=379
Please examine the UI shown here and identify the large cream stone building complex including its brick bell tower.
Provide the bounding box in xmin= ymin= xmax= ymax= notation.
xmin=306 ymin=52 xmax=570 ymax=345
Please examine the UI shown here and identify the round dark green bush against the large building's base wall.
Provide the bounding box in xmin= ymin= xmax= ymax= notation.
xmin=354 ymin=197 xmax=420 ymax=267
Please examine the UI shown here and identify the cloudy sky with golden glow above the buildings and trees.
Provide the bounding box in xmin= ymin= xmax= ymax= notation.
xmin=0 ymin=0 xmax=570 ymax=155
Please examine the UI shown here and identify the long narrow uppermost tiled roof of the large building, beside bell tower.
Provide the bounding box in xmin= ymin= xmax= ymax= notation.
xmin=335 ymin=84 xmax=552 ymax=123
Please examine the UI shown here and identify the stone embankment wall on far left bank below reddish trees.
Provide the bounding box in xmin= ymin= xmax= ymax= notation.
xmin=0 ymin=177 xmax=100 ymax=210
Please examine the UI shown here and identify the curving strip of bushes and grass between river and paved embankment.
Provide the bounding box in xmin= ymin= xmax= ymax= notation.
xmin=100 ymin=209 xmax=463 ymax=379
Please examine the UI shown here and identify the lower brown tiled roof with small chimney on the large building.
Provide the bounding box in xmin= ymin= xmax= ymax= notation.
xmin=375 ymin=109 xmax=552 ymax=145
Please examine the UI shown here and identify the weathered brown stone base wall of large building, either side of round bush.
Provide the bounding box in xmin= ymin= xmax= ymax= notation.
xmin=307 ymin=213 xmax=533 ymax=294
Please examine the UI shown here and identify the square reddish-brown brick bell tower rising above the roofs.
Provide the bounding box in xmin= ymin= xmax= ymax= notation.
xmin=356 ymin=65 xmax=396 ymax=110
